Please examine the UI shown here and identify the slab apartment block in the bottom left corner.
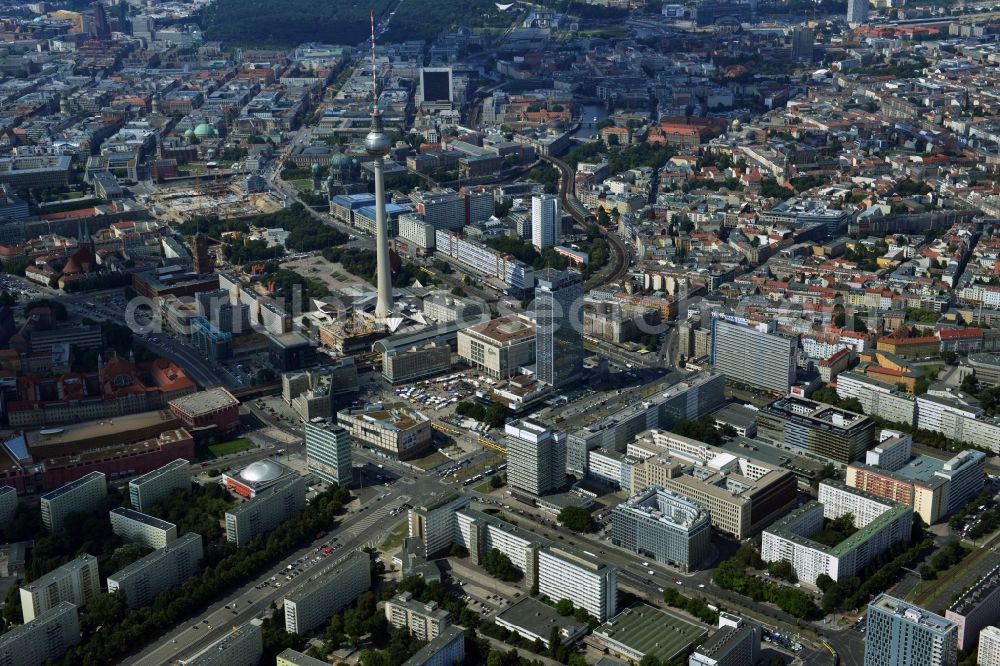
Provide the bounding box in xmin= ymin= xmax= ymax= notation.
xmin=0 ymin=601 xmax=80 ymax=666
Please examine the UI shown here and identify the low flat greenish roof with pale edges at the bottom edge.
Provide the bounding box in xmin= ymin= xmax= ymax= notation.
xmin=594 ymin=603 xmax=708 ymax=661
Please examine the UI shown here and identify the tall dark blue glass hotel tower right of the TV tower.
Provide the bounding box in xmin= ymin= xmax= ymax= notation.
xmin=535 ymin=268 xmax=583 ymax=388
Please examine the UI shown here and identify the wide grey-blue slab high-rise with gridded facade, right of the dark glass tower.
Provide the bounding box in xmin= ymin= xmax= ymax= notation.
xmin=710 ymin=317 xmax=795 ymax=394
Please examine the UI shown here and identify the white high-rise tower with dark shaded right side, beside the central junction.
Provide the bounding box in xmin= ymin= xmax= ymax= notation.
xmin=504 ymin=419 xmax=566 ymax=496
